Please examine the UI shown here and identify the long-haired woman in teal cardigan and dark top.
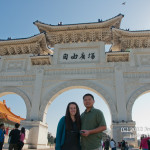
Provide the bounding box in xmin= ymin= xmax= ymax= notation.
xmin=56 ymin=102 xmax=81 ymax=150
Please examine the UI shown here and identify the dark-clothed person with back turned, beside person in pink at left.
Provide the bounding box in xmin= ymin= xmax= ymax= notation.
xmin=9 ymin=123 xmax=20 ymax=150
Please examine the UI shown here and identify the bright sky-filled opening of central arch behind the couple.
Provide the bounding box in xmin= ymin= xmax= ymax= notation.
xmin=46 ymin=86 xmax=112 ymax=145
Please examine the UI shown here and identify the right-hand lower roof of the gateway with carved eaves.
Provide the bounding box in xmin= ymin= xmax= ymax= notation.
xmin=111 ymin=28 xmax=150 ymax=51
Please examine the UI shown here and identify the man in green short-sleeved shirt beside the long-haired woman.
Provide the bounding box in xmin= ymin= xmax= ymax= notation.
xmin=81 ymin=94 xmax=106 ymax=150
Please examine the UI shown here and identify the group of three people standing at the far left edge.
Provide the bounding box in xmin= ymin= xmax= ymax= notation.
xmin=0 ymin=123 xmax=25 ymax=150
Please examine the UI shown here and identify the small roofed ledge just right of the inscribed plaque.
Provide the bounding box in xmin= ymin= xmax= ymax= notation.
xmin=106 ymin=52 xmax=129 ymax=62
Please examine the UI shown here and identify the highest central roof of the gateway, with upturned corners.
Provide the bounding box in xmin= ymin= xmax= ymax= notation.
xmin=34 ymin=14 xmax=124 ymax=47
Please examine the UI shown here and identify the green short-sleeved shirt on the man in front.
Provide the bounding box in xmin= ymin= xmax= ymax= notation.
xmin=81 ymin=107 xmax=106 ymax=150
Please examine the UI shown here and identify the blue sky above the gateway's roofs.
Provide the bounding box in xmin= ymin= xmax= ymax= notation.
xmin=0 ymin=0 xmax=150 ymax=39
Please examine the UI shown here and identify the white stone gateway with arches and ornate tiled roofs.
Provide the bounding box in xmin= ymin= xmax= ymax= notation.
xmin=0 ymin=14 xmax=150 ymax=149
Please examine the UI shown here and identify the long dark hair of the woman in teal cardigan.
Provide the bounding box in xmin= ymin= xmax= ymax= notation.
xmin=66 ymin=102 xmax=81 ymax=130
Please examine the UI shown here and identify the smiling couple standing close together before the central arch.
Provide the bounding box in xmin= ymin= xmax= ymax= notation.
xmin=55 ymin=94 xmax=106 ymax=150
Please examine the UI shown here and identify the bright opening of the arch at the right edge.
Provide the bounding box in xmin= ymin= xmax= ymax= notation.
xmin=131 ymin=90 xmax=150 ymax=142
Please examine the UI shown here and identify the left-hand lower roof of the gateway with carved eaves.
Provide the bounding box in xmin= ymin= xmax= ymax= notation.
xmin=0 ymin=33 xmax=53 ymax=56
